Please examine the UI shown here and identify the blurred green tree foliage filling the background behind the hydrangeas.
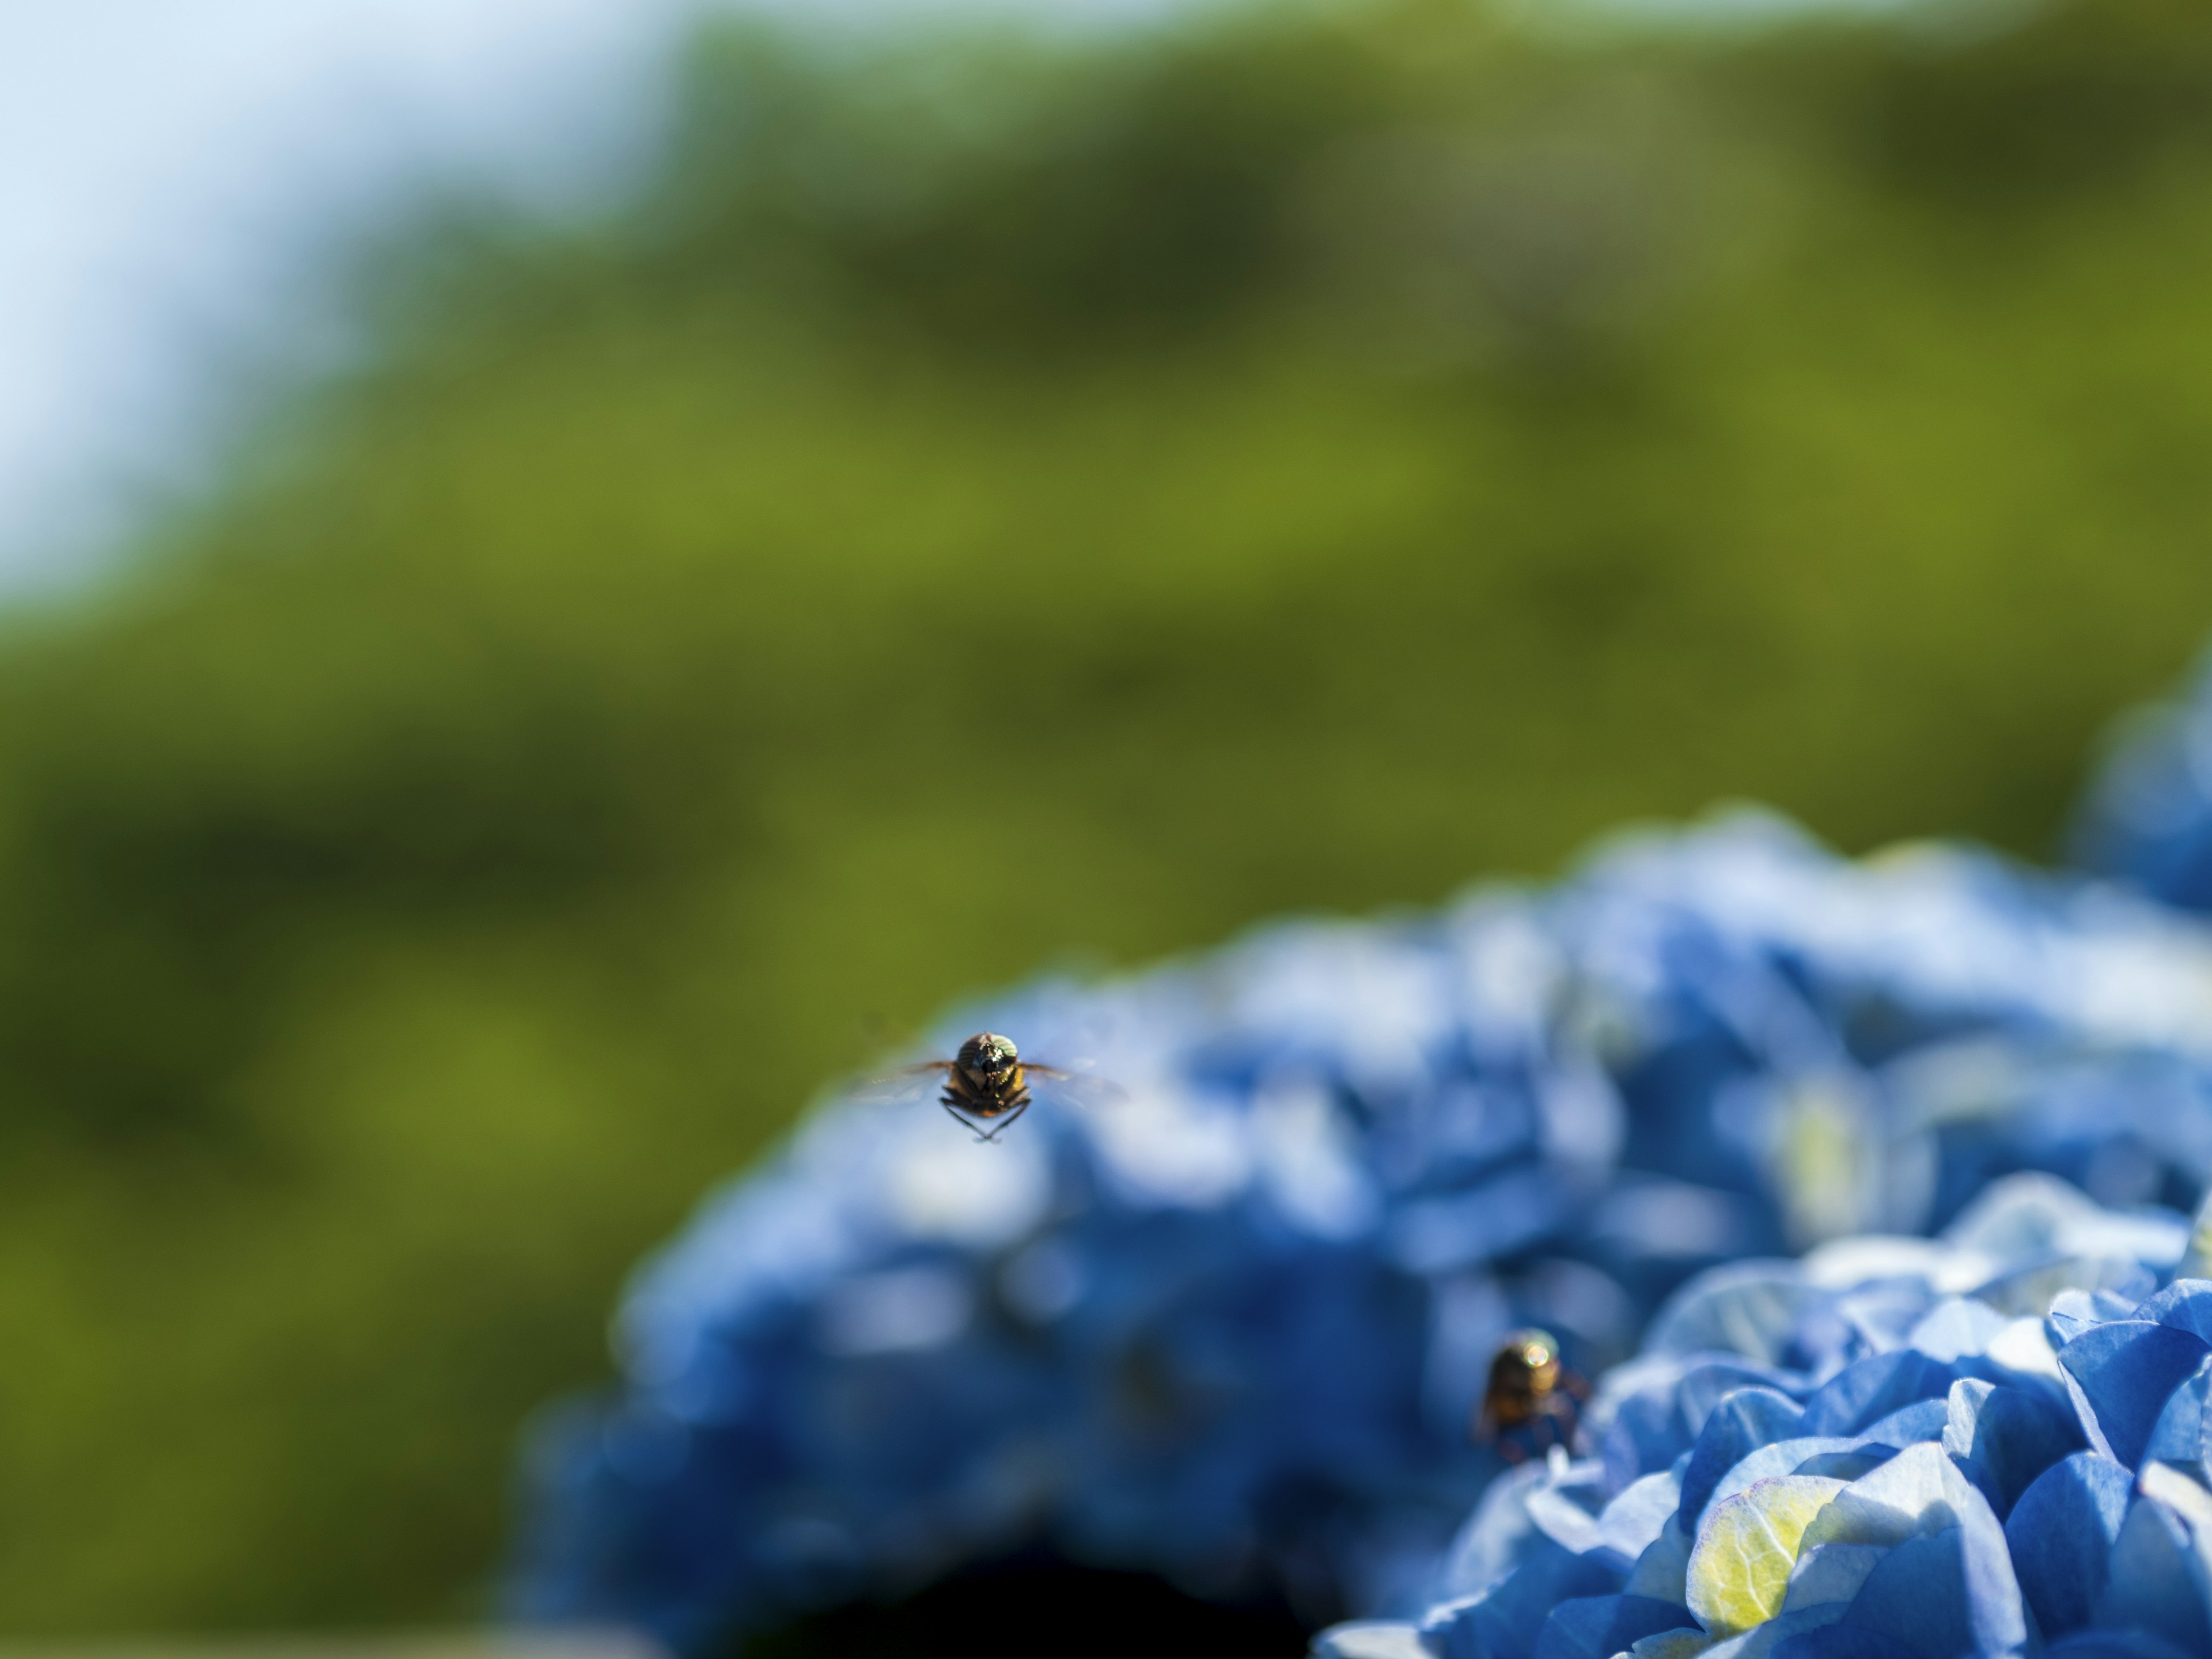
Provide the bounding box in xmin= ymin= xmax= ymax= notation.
xmin=0 ymin=0 xmax=2212 ymax=1630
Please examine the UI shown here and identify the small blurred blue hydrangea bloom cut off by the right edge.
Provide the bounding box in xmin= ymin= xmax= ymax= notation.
xmin=2073 ymin=659 xmax=2212 ymax=909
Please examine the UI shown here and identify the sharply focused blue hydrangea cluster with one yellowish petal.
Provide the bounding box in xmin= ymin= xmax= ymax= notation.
xmin=1316 ymin=1177 xmax=2212 ymax=1659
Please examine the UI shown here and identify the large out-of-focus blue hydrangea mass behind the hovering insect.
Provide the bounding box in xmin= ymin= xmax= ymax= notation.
xmin=518 ymin=816 xmax=2212 ymax=1652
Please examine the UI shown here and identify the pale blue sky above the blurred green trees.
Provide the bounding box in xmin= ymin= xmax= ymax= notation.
xmin=0 ymin=0 xmax=1902 ymax=588
